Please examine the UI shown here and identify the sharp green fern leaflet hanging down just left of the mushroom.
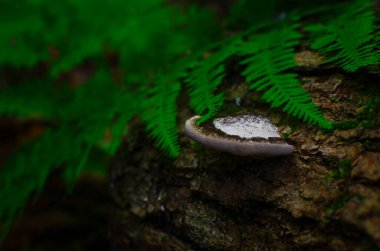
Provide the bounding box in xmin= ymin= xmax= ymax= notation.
xmin=142 ymin=75 xmax=181 ymax=157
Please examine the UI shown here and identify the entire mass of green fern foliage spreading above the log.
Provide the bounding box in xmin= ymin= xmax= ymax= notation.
xmin=0 ymin=0 xmax=380 ymax=240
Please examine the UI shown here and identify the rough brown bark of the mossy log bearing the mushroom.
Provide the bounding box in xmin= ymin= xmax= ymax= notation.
xmin=110 ymin=51 xmax=380 ymax=251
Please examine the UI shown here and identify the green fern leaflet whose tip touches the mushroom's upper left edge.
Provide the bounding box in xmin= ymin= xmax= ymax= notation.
xmin=186 ymin=40 xmax=240 ymax=123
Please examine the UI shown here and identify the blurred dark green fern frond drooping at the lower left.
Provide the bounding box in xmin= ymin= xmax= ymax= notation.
xmin=0 ymin=71 xmax=136 ymax=236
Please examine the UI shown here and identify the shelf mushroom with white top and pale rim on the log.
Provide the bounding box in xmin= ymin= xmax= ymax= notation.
xmin=185 ymin=114 xmax=294 ymax=158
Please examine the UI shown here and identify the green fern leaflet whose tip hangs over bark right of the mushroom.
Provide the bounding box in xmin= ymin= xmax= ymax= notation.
xmin=240 ymin=23 xmax=331 ymax=128
